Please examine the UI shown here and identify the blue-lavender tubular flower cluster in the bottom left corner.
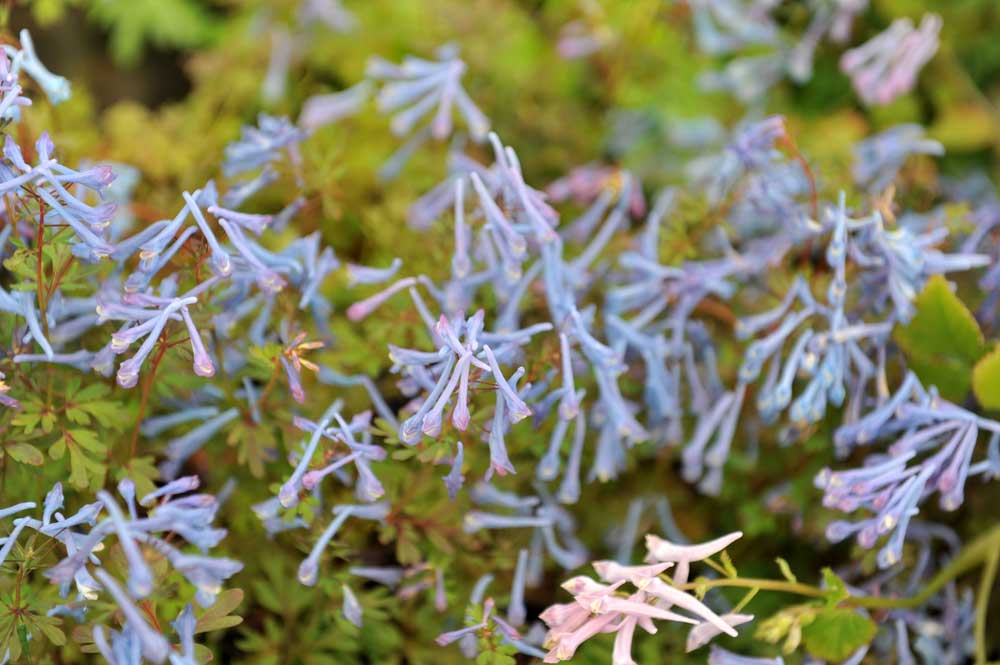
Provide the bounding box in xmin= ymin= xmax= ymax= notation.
xmin=0 ymin=476 xmax=243 ymax=665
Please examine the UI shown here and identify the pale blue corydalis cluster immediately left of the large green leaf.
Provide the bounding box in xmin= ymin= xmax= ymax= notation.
xmin=736 ymin=195 xmax=989 ymax=440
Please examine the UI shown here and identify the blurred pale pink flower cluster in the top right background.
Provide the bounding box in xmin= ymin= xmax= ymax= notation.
xmin=840 ymin=14 xmax=941 ymax=106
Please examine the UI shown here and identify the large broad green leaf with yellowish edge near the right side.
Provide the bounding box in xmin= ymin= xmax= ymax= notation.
xmin=896 ymin=275 xmax=985 ymax=402
